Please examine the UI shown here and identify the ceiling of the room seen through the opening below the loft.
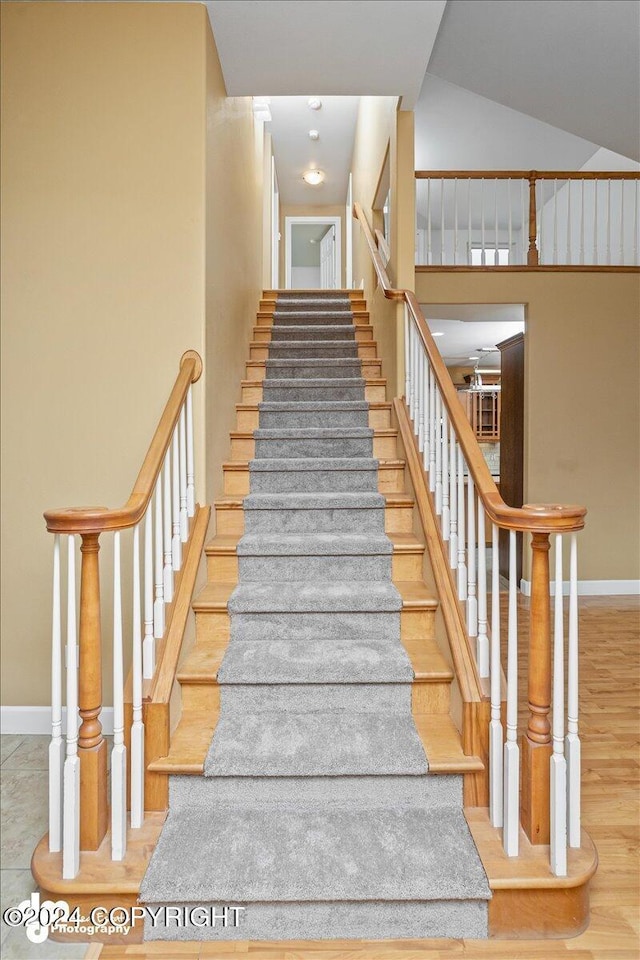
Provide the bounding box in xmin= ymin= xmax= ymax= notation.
xmin=421 ymin=303 xmax=524 ymax=370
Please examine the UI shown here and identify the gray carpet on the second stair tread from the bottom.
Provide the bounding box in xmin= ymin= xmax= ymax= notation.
xmin=204 ymin=712 xmax=427 ymax=777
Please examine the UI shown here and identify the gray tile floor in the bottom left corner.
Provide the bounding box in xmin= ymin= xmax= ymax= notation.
xmin=0 ymin=734 xmax=88 ymax=960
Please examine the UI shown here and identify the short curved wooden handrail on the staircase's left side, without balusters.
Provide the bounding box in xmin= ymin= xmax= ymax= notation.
xmin=44 ymin=350 xmax=202 ymax=534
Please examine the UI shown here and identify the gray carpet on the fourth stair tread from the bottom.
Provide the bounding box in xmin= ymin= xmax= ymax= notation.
xmin=228 ymin=580 xmax=402 ymax=615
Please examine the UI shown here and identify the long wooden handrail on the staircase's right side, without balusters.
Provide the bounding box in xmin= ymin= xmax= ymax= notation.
xmin=353 ymin=203 xmax=587 ymax=533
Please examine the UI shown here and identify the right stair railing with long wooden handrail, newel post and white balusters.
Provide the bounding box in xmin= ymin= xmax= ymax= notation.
xmin=354 ymin=204 xmax=586 ymax=876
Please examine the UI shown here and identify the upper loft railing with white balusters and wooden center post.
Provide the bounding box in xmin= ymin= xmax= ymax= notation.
xmin=415 ymin=170 xmax=640 ymax=269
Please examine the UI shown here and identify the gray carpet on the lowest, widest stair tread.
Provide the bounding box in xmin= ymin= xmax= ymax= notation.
xmin=140 ymin=778 xmax=490 ymax=903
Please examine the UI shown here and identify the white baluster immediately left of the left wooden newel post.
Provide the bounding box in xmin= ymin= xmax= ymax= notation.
xmin=62 ymin=535 xmax=80 ymax=880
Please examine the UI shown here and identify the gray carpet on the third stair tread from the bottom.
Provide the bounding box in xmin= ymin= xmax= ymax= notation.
xmin=217 ymin=637 xmax=414 ymax=684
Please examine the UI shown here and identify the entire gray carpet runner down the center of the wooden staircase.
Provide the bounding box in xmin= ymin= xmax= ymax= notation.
xmin=140 ymin=293 xmax=490 ymax=940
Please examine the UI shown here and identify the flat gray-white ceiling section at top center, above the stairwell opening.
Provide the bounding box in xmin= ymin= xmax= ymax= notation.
xmin=206 ymin=0 xmax=445 ymax=109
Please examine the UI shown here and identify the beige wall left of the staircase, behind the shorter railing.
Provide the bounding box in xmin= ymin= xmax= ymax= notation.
xmin=0 ymin=2 xmax=262 ymax=705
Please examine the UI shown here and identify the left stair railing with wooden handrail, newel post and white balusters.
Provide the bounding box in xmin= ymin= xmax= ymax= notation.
xmin=44 ymin=350 xmax=202 ymax=879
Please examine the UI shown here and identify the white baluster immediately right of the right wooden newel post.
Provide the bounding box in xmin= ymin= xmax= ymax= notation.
xmin=549 ymin=534 xmax=567 ymax=877
